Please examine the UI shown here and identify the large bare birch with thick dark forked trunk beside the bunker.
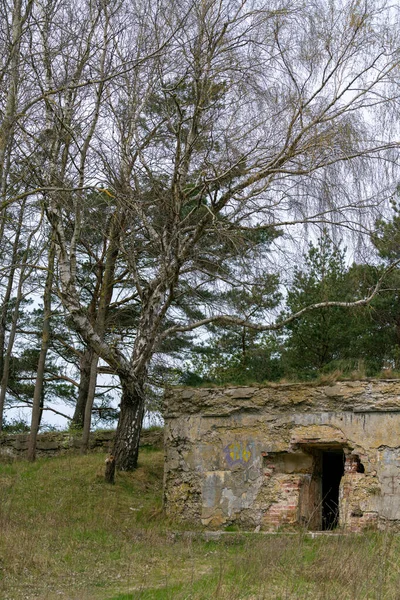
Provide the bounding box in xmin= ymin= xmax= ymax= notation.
xmin=38 ymin=0 xmax=398 ymax=469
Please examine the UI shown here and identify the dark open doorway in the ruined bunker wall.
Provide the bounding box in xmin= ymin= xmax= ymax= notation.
xmin=322 ymin=450 xmax=345 ymax=531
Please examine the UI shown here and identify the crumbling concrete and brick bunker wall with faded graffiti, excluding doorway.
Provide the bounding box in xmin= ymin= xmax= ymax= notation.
xmin=165 ymin=380 xmax=400 ymax=531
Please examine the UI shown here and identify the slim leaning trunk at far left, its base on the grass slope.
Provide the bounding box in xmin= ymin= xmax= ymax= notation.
xmin=28 ymin=236 xmax=56 ymax=461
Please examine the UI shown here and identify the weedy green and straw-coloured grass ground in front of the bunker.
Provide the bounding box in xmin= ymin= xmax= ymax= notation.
xmin=0 ymin=450 xmax=400 ymax=600
